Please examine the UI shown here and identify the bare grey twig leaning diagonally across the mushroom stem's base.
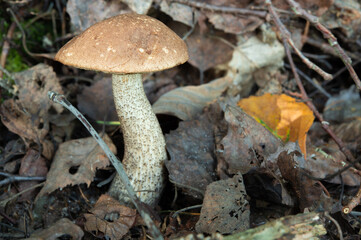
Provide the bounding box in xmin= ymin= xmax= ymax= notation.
xmin=48 ymin=91 xmax=163 ymax=240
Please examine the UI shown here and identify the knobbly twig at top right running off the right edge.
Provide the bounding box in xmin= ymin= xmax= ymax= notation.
xmin=287 ymin=0 xmax=361 ymax=90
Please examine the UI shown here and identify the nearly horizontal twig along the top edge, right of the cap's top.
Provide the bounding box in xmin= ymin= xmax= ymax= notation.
xmin=170 ymin=0 xmax=267 ymax=18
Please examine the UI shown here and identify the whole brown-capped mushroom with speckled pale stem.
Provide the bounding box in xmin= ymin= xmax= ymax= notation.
xmin=55 ymin=13 xmax=188 ymax=205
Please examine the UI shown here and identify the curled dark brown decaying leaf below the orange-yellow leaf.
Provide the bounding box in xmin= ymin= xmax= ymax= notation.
xmin=261 ymin=142 xmax=322 ymax=210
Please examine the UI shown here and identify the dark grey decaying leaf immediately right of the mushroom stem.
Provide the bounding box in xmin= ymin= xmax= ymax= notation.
xmin=165 ymin=108 xmax=221 ymax=198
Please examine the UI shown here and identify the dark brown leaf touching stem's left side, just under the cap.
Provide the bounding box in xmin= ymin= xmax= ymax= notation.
xmin=77 ymin=78 xmax=119 ymax=121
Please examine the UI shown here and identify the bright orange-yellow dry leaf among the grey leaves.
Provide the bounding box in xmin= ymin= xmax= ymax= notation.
xmin=238 ymin=93 xmax=315 ymax=156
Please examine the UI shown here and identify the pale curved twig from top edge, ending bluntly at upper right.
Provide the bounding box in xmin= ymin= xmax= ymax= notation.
xmin=265 ymin=0 xmax=332 ymax=80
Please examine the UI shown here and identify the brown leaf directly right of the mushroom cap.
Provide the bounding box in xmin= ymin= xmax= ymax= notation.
xmin=186 ymin=25 xmax=234 ymax=71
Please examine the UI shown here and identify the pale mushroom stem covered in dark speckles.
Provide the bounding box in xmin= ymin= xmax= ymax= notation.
xmin=109 ymin=74 xmax=167 ymax=205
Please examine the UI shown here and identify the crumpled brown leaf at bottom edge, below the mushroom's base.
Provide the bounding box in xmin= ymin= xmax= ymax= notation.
xmin=84 ymin=195 xmax=136 ymax=239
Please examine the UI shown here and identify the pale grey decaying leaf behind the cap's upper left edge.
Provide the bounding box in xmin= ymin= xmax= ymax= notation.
xmin=66 ymin=0 xmax=129 ymax=32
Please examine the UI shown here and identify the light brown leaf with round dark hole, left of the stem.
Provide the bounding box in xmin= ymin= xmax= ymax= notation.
xmin=37 ymin=135 xmax=116 ymax=198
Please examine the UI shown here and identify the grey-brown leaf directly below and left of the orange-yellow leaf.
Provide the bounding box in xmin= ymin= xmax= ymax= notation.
xmin=217 ymin=106 xmax=282 ymax=174
